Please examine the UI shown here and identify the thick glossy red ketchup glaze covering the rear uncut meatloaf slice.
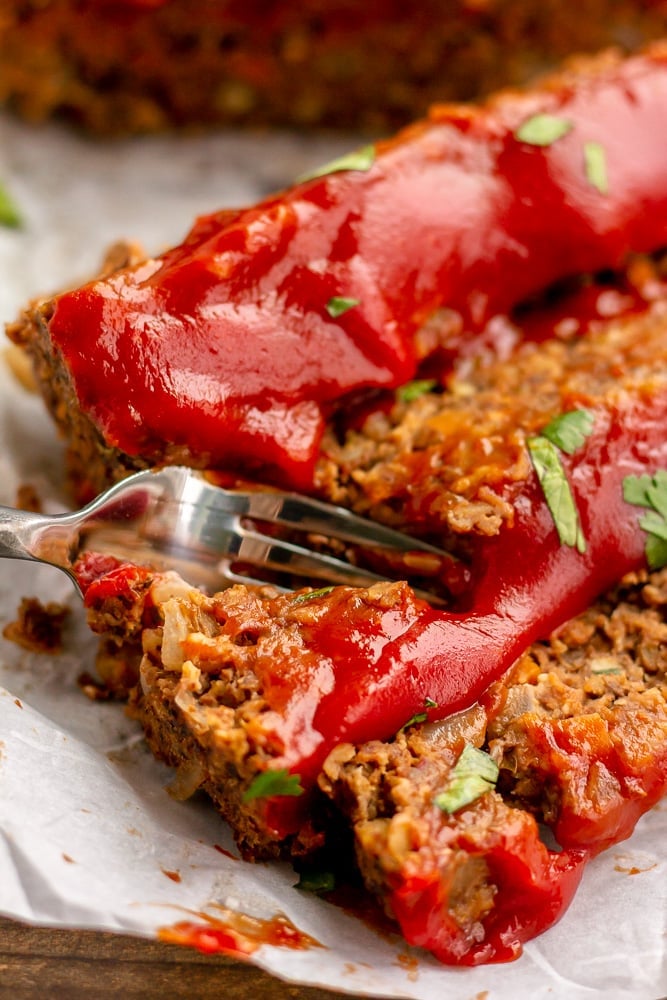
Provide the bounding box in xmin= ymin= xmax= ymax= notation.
xmin=50 ymin=47 xmax=667 ymax=488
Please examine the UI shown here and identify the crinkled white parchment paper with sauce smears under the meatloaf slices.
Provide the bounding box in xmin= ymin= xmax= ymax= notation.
xmin=0 ymin=111 xmax=667 ymax=1000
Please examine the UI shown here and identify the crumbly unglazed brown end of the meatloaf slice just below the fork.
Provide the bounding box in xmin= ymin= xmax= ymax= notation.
xmin=81 ymin=564 xmax=430 ymax=858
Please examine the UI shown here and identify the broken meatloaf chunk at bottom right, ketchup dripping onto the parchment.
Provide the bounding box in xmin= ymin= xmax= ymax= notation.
xmin=320 ymin=570 xmax=667 ymax=962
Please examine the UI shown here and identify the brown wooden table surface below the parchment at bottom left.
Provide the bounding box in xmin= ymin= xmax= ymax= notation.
xmin=0 ymin=918 xmax=358 ymax=1000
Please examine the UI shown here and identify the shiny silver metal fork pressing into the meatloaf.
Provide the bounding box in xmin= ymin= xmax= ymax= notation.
xmin=0 ymin=466 xmax=452 ymax=596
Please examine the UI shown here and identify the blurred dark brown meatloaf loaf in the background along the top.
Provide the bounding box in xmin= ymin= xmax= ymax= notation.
xmin=0 ymin=0 xmax=667 ymax=134
